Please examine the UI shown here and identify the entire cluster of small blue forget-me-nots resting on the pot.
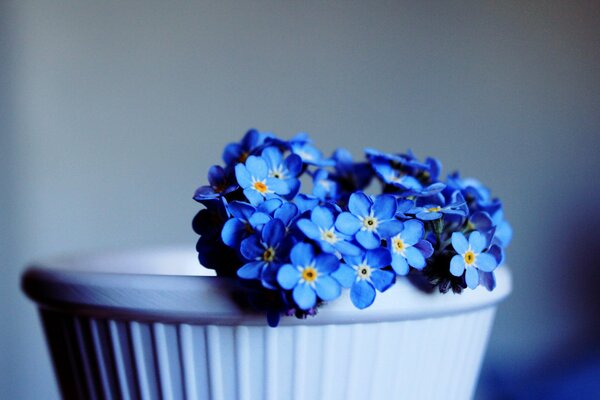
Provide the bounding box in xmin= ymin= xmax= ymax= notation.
xmin=193 ymin=130 xmax=512 ymax=324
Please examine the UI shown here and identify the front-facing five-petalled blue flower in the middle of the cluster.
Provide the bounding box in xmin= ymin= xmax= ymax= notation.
xmin=335 ymin=192 xmax=402 ymax=249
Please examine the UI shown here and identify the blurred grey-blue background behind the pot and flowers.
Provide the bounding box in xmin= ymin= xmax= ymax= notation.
xmin=0 ymin=0 xmax=600 ymax=399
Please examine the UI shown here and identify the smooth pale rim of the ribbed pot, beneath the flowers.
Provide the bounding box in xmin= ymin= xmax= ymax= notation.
xmin=21 ymin=248 xmax=512 ymax=326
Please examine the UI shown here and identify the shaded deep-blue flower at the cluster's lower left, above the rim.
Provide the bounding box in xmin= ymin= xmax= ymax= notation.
xmin=237 ymin=219 xmax=289 ymax=289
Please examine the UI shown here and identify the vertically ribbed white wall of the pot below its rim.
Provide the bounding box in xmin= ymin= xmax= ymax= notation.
xmin=41 ymin=307 xmax=495 ymax=400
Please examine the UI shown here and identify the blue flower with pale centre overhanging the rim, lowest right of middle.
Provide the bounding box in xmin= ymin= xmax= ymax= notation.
xmin=332 ymin=247 xmax=395 ymax=310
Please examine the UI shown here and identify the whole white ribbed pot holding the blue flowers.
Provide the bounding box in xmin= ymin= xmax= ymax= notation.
xmin=23 ymin=249 xmax=511 ymax=400
